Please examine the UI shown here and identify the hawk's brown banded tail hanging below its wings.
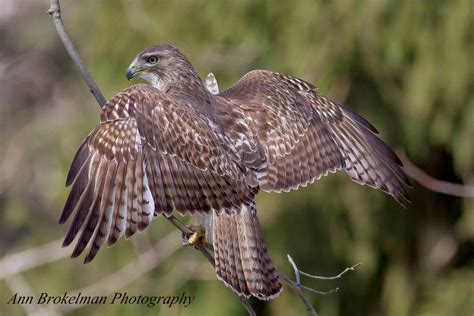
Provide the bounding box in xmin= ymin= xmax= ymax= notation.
xmin=213 ymin=204 xmax=282 ymax=300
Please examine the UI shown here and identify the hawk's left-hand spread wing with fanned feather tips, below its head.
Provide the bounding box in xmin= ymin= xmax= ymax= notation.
xmin=59 ymin=85 xmax=256 ymax=262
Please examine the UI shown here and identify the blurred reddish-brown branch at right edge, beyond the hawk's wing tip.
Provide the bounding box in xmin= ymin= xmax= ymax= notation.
xmin=397 ymin=150 xmax=474 ymax=198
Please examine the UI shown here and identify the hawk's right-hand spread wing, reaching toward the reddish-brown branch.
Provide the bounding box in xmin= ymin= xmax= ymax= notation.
xmin=219 ymin=70 xmax=409 ymax=204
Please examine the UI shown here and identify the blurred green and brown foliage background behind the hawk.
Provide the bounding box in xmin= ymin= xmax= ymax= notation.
xmin=0 ymin=0 xmax=474 ymax=316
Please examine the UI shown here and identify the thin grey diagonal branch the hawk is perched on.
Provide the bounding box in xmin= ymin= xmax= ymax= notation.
xmin=48 ymin=0 xmax=256 ymax=315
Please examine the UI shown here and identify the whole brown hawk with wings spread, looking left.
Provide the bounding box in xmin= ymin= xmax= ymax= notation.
xmin=60 ymin=44 xmax=408 ymax=300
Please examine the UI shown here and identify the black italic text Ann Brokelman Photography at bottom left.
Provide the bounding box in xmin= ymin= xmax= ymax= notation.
xmin=7 ymin=292 xmax=196 ymax=307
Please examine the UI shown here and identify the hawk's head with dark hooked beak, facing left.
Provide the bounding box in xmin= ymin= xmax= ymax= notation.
xmin=125 ymin=44 xmax=196 ymax=90
